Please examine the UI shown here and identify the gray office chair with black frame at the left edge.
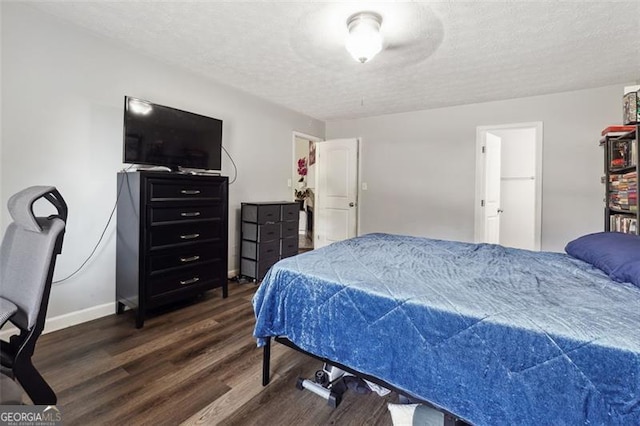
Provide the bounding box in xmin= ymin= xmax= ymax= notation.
xmin=0 ymin=186 xmax=67 ymax=405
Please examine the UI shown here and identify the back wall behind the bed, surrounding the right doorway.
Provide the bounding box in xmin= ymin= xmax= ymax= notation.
xmin=327 ymin=82 xmax=623 ymax=251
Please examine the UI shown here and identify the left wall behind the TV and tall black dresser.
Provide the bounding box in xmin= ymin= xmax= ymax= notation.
xmin=0 ymin=3 xmax=324 ymax=317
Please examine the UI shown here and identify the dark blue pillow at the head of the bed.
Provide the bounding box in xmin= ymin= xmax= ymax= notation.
xmin=565 ymin=232 xmax=640 ymax=287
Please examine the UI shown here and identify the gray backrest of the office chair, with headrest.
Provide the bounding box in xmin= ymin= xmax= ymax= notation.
xmin=0 ymin=186 xmax=67 ymax=331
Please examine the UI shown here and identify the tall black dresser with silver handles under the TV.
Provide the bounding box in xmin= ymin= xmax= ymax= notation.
xmin=116 ymin=171 xmax=228 ymax=328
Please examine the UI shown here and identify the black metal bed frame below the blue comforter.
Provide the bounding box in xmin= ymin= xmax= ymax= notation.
xmin=262 ymin=336 xmax=470 ymax=426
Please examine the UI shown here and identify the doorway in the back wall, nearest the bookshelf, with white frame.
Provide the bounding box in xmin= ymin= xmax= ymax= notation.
xmin=475 ymin=122 xmax=542 ymax=250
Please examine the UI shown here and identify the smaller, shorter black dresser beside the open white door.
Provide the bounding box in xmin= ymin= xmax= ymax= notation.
xmin=240 ymin=201 xmax=300 ymax=281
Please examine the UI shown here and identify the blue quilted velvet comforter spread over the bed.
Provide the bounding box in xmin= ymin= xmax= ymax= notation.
xmin=253 ymin=234 xmax=640 ymax=426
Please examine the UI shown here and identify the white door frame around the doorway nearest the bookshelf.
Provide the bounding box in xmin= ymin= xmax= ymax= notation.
xmin=474 ymin=121 xmax=543 ymax=250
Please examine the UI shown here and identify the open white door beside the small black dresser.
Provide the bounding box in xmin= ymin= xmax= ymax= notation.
xmin=314 ymin=139 xmax=358 ymax=248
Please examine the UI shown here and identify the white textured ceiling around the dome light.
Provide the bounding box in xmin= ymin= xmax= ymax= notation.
xmin=26 ymin=1 xmax=640 ymax=120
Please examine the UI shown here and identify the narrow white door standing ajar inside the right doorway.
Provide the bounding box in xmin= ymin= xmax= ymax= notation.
xmin=483 ymin=133 xmax=502 ymax=244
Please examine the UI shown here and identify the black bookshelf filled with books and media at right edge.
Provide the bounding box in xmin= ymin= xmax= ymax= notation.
xmin=600 ymin=124 xmax=640 ymax=235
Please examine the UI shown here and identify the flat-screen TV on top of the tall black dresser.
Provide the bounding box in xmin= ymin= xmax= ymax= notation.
xmin=123 ymin=96 xmax=222 ymax=170
